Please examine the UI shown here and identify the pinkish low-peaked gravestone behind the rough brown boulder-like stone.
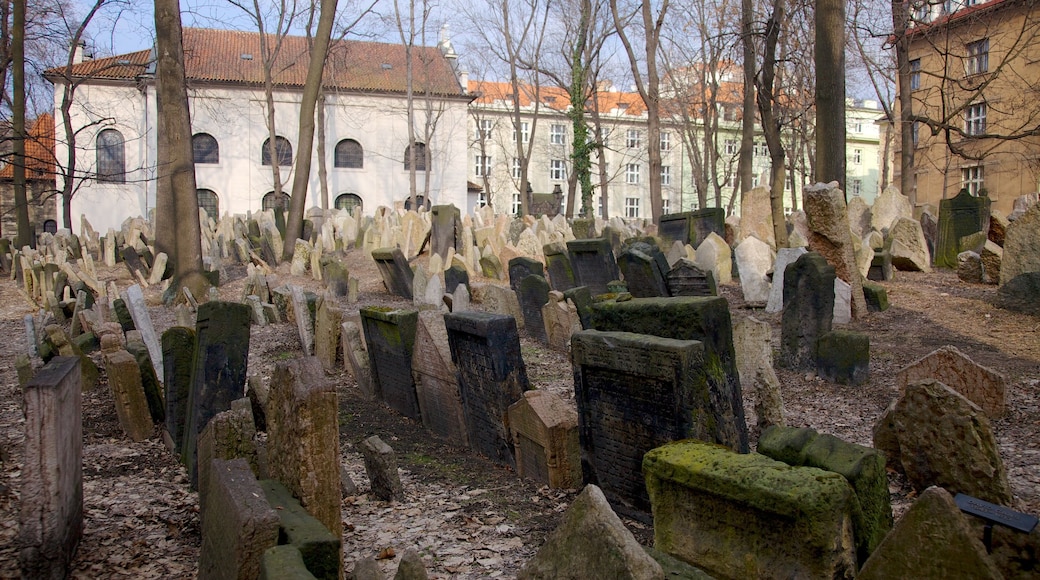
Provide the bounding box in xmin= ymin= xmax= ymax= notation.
xmin=895 ymin=345 xmax=1007 ymax=419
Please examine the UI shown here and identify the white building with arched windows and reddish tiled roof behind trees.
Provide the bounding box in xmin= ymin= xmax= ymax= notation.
xmin=46 ymin=28 xmax=470 ymax=236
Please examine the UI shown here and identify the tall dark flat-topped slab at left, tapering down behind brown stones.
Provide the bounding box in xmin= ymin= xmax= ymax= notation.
xmin=182 ymin=301 xmax=250 ymax=484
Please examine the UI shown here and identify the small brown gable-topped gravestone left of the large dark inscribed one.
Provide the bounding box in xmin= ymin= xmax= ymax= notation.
xmin=508 ymin=390 xmax=581 ymax=489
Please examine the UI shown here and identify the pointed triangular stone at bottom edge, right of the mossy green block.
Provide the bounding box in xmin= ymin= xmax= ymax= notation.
xmin=856 ymin=487 xmax=1004 ymax=580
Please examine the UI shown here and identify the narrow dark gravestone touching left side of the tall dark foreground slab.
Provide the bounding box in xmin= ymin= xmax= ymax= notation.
xmin=162 ymin=326 xmax=194 ymax=455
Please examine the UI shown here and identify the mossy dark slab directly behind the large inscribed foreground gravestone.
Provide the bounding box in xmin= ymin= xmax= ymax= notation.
xmin=592 ymin=296 xmax=748 ymax=453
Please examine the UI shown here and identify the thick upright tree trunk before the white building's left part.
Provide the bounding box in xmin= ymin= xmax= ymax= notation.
xmin=155 ymin=0 xmax=209 ymax=296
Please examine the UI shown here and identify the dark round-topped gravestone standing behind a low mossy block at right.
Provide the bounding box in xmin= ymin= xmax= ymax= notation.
xmin=778 ymin=252 xmax=834 ymax=370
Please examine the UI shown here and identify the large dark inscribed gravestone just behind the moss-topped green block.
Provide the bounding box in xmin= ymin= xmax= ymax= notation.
xmin=571 ymin=331 xmax=721 ymax=515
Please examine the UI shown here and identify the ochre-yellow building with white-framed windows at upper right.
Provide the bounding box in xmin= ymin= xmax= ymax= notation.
xmin=895 ymin=0 xmax=1040 ymax=215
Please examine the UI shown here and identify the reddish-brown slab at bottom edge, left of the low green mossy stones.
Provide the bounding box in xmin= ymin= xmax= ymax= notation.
xmin=199 ymin=458 xmax=279 ymax=580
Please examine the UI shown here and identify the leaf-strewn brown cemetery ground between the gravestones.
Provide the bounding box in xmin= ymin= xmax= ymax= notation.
xmin=0 ymin=251 xmax=1040 ymax=578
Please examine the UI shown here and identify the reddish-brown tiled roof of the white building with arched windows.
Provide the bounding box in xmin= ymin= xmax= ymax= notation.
xmin=48 ymin=28 xmax=463 ymax=97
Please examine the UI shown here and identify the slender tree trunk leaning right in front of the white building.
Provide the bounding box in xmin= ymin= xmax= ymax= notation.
xmin=282 ymin=0 xmax=338 ymax=261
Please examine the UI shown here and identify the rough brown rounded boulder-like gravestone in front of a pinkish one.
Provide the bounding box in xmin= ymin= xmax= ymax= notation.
xmin=874 ymin=378 xmax=1012 ymax=505
